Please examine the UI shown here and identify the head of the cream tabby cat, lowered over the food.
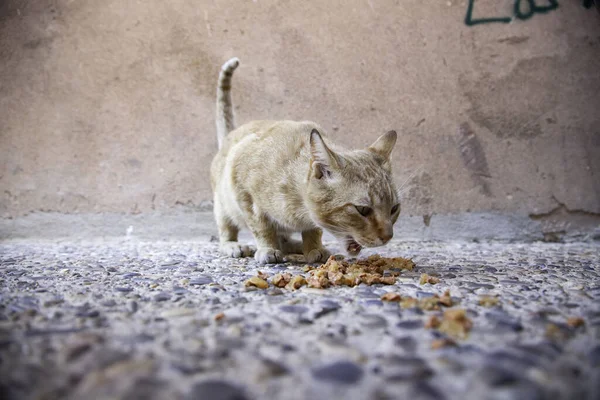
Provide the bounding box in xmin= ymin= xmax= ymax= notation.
xmin=307 ymin=129 xmax=400 ymax=255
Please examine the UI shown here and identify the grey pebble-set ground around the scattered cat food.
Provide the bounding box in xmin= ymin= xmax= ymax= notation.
xmin=0 ymin=240 xmax=600 ymax=400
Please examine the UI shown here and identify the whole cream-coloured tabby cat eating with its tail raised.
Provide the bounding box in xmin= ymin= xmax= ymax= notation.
xmin=211 ymin=58 xmax=400 ymax=263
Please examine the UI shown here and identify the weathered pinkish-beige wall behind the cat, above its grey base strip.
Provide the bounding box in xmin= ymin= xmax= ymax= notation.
xmin=0 ymin=0 xmax=600 ymax=238
